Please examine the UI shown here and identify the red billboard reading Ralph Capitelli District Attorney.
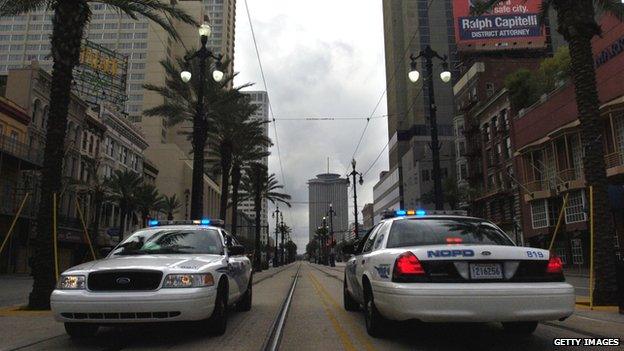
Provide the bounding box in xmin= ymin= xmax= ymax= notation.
xmin=453 ymin=0 xmax=547 ymax=51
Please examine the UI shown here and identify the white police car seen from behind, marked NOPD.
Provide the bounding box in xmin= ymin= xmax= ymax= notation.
xmin=344 ymin=210 xmax=575 ymax=336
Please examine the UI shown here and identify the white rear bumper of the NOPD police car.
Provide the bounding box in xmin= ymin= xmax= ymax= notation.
xmin=373 ymin=282 xmax=575 ymax=322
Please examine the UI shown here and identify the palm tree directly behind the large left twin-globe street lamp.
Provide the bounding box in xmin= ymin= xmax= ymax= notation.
xmin=143 ymin=55 xmax=247 ymax=218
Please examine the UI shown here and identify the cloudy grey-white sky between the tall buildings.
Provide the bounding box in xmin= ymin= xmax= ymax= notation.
xmin=235 ymin=0 xmax=388 ymax=252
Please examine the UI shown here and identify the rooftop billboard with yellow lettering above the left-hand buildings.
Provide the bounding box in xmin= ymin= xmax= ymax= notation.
xmin=74 ymin=40 xmax=128 ymax=112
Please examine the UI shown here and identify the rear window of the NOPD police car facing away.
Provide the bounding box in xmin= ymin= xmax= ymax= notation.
xmin=386 ymin=218 xmax=513 ymax=248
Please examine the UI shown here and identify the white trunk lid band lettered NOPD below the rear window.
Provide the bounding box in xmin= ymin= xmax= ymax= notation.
xmin=389 ymin=244 xmax=550 ymax=261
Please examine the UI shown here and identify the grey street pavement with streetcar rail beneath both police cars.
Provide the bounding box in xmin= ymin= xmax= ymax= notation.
xmin=0 ymin=262 xmax=624 ymax=350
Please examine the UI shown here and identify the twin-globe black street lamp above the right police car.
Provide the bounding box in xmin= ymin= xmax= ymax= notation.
xmin=408 ymin=45 xmax=451 ymax=210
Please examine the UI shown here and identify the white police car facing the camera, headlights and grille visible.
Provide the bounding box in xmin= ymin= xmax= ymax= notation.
xmin=51 ymin=219 xmax=252 ymax=337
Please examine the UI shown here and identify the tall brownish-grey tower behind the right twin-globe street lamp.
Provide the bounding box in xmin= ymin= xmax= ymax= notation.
xmin=375 ymin=0 xmax=457 ymax=209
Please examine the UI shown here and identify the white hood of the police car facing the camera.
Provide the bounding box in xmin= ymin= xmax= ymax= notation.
xmin=66 ymin=255 xmax=223 ymax=273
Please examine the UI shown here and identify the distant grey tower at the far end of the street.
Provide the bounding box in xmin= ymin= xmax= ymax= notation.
xmin=308 ymin=173 xmax=349 ymax=242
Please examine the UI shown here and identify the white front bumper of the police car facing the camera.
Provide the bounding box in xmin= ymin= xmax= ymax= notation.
xmin=50 ymin=287 xmax=217 ymax=324
